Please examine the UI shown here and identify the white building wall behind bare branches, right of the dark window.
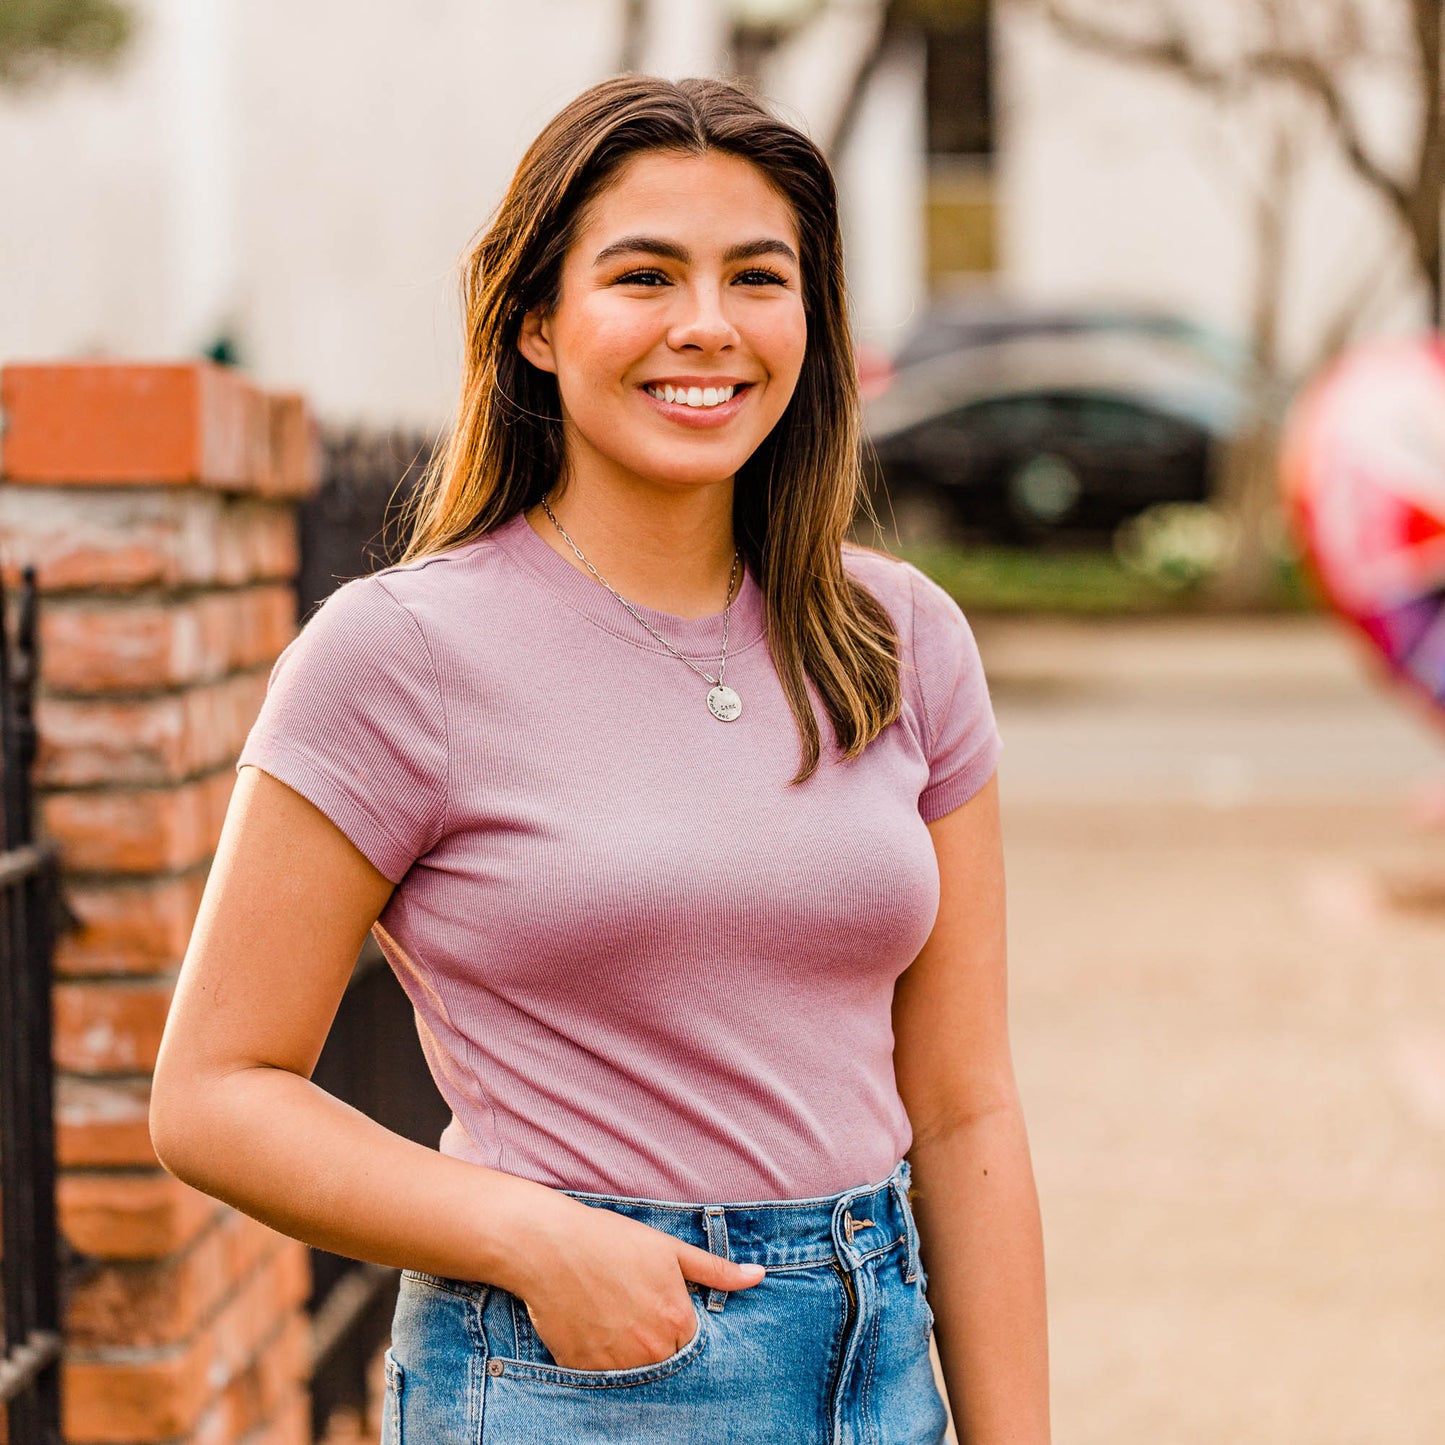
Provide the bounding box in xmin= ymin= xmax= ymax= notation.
xmin=996 ymin=0 xmax=1422 ymax=366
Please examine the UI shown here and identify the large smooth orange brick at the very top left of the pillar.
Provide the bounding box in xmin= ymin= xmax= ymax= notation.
xmin=0 ymin=361 xmax=264 ymax=487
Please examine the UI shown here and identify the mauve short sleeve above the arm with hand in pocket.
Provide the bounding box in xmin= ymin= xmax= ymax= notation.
xmin=236 ymin=577 xmax=448 ymax=883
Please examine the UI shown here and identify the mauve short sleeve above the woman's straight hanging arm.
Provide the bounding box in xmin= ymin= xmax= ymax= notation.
xmin=910 ymin=568 xmax=1003 ymax=822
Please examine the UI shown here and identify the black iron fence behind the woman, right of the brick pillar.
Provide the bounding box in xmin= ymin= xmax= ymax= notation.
xmin=306 ymin=431 xmax=451 ymax=1439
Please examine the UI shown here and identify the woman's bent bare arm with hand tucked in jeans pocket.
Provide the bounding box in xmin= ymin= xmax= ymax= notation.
xmin=150 ymin=767 xmax=754 ymax=1370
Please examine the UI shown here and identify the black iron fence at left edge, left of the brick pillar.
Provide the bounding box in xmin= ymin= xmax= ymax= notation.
xmin=0 ymin=568 xmax=61 ymax=1445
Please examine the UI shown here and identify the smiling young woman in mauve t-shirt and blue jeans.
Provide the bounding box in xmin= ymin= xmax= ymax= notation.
xmin=152 ymin=78 xmax=1048 ymax=1445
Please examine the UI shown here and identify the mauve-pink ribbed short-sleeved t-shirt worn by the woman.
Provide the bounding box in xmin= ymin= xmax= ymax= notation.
xmin=237 ymin=513 xmax=1000 ymax=1202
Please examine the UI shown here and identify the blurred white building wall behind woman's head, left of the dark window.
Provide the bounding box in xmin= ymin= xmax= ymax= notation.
xmin=0 ymin=0 xmax=922 ymax=426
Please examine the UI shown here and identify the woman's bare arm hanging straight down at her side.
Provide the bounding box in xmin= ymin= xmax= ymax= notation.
xmin=893 ymin=777 xmax=1049 ymax=1445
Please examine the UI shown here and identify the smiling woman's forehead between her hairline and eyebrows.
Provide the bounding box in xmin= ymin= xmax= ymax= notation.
xmin=577 ymin=150 xmax=798 ymax=260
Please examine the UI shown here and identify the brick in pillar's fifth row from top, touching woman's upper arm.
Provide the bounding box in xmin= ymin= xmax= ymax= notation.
xmin=40 ymin=767 xmax=236 ymax=874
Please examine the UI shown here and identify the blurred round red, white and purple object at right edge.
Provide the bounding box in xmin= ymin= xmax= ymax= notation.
xmin=1282 ymin=335 xmax=1445 ymax=712
